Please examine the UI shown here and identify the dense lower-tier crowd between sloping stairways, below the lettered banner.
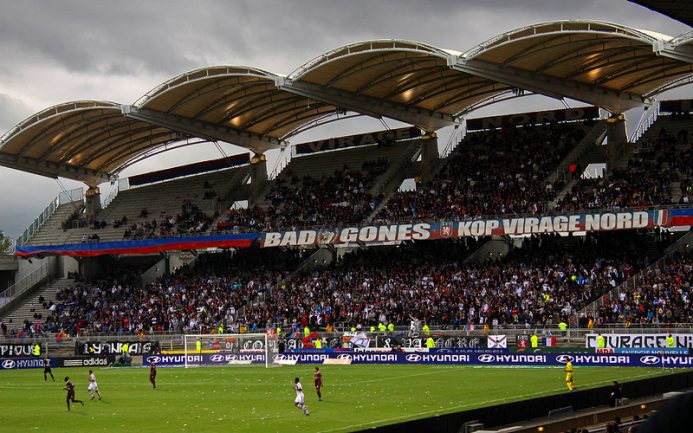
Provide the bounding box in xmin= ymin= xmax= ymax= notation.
xmin=248 ymin=233 xmax=668 ymax=328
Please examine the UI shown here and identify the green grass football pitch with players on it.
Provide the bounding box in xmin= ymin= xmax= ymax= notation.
xmin=0 ymin=365 xmax=667 ymax=433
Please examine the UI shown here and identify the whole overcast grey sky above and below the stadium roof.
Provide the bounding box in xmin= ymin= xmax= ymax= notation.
xmin=0 ymin=0 xmax=690 ymax=237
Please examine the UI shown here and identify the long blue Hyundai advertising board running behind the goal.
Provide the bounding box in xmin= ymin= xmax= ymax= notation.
xmin=143 ymin=351 xmax=693 ymax=368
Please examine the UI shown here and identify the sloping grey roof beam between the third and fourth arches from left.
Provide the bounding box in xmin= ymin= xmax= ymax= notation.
xmin=449 ymin=58 xmax=653 ymax=113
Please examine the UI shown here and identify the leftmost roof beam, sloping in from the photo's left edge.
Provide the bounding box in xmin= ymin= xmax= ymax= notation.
xmin=0 ymin=152 xmax=109 ymax=186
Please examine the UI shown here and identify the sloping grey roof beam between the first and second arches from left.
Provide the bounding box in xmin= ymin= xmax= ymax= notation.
xmin=122 ymin=105 xmax=286 ymax=153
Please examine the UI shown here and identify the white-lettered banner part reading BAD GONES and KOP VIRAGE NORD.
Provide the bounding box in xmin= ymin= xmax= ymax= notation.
xmin=260 ymin=208 xmax=693 ymax=248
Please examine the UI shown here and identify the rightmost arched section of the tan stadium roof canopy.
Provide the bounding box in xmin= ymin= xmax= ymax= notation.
xmin=453 ymin=20 xmax=693 ymax=113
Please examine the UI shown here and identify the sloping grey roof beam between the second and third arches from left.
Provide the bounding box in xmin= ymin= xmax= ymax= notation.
xmin=275 ymin=77 xmax=459 ymax=131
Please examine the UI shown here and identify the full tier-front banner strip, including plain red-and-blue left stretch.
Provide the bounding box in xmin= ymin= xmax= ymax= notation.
xmin=16 ymin=208 xmax=693 ymax=258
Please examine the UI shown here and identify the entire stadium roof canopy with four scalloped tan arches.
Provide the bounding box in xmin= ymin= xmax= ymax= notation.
xmin=0 ymin=20 xmax=693 ymax=185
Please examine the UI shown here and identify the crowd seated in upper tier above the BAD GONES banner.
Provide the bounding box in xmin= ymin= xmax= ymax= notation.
xmin=59 ymin=115 xmax=693 ymax=246
